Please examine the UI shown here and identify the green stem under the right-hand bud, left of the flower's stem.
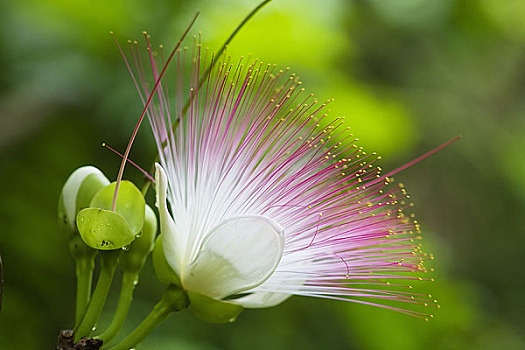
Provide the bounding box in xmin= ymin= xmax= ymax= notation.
xmin=97 ymin=273 xmax=139 ymax=344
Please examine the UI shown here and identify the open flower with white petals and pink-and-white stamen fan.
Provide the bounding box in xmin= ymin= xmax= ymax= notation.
xmin=122 ymin=35 xmax=433 ymax=318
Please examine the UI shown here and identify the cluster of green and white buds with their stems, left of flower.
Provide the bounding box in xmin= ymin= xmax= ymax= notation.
xmin=58 ymin=166 xmax=157 ymax=340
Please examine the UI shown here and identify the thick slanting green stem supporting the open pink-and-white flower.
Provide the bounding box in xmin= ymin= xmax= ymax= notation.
xmin=109 ymin=285 xmax=189 ymax=350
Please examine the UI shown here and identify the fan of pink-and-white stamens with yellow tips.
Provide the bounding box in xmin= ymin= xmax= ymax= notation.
xmin=125 ymin=20 xmax=448 ymax=318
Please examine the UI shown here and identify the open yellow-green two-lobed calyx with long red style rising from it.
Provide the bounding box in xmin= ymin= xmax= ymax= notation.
xmin=77 ymin=181 xmax=146 ymax=250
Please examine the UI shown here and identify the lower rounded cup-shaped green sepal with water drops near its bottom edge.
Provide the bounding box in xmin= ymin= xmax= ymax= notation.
xmin=77 ymin=208 xmax=135 ymax=250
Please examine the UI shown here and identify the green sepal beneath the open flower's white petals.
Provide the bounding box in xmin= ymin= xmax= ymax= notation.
xmin=188 ymin=291 xmax=244 ymax=323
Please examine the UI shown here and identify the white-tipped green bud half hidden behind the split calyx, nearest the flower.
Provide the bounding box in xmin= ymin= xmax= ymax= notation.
xmin=120 ymin=205 xmax=157 ymax=274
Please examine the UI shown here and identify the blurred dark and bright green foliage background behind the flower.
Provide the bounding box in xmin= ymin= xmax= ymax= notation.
xmin=0 ymin=0 xmax=525 ymax=349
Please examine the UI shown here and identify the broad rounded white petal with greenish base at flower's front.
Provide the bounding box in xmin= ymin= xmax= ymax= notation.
xmin=182 ymin=215 xmax=284 ymax=299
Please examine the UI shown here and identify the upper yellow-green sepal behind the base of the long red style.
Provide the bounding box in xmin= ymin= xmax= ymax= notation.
xmin=89 ymin=181 xmax=146 ymax=235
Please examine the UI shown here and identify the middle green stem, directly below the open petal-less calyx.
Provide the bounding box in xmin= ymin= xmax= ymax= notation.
xmin=75 ymin=249 xmax=122 ymax=340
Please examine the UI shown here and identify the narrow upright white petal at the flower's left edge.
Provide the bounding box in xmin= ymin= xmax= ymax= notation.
xmin=155 ymin=163 xmax=184 ymax=276
